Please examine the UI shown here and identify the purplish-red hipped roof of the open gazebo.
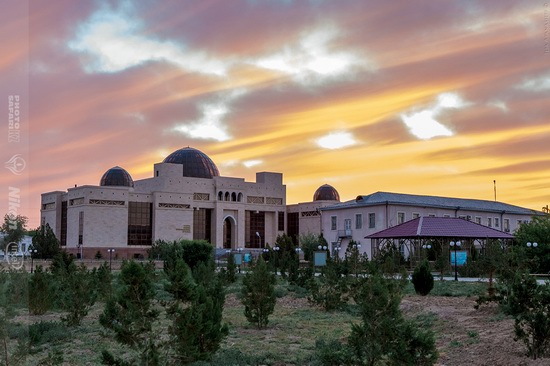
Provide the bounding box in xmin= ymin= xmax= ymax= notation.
xmin=365 ymin=217 xmax=514 ymax=239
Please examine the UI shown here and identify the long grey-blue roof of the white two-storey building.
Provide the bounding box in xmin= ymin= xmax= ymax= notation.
xmin=323 ymin=192 xmax=540 ymax=215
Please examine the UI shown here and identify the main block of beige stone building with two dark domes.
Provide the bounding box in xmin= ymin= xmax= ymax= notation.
xmin=41 ymin=147 xmax=286 ymax=258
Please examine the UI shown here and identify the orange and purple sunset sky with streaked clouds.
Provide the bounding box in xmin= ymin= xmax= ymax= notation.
xmin=0 ymin=0 xmax=550 ymax=227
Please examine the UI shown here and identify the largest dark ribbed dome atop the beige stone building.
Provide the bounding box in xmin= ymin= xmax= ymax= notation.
xmin=163 ymin=147 xmax=220 ymax=178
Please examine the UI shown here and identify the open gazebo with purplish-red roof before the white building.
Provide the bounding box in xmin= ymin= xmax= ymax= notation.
xmin=365 ymin=217 xmax=514 ymax=268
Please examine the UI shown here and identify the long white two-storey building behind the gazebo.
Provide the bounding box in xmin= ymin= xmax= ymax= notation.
xmin=321 ymin=192 xmax=543 ymax=258
